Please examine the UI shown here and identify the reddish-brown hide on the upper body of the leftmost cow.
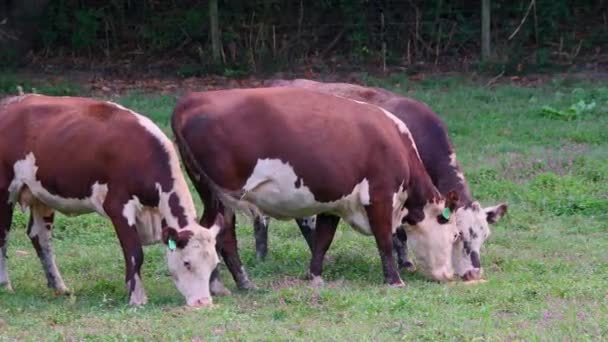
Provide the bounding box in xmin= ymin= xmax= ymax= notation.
xmin=0 ymin=95 xmax=172 ymax=206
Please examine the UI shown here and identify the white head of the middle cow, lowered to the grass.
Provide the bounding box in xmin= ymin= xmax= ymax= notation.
xmin=405 ymin=191 xmax=459 ymax=281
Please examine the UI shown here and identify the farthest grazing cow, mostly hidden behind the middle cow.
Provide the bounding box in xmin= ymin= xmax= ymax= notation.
xmin=254 ymin=79 xmax=507 ymax=280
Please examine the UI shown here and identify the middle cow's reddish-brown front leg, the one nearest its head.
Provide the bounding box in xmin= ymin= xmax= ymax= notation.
xmin=366 ymin=203 xmax=405 ymax=286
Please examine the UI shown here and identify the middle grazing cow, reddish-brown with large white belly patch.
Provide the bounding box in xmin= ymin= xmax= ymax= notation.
xmin=172 ymin=88 xmax=458 ymax=288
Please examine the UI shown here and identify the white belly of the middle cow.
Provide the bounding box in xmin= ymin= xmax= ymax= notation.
xmin=242 ymin=159 xmax=371 ymax=235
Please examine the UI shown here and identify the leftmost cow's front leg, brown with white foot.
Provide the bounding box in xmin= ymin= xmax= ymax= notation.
xmin=104 ymin=195 xmax=148 ymax=305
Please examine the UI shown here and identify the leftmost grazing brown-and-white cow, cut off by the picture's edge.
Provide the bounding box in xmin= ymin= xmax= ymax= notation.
xmin=0 ymin=95 xmax=223 ymax=306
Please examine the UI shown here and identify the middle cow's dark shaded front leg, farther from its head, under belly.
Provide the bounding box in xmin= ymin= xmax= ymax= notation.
xmin=309 ymin=214 xmax=340 ymax=286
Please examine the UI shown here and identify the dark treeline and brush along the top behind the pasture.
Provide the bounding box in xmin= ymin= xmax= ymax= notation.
xmin=0 ymin=0 xmax=608 ymax=73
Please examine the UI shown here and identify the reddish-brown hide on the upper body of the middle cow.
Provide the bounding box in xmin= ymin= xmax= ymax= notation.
xmin=173 ymin=88 xmax=411 ymax=207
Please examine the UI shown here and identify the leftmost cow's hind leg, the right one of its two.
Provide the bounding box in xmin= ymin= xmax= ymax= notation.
xmin=27 ymin=203 xmax=70 ymax=294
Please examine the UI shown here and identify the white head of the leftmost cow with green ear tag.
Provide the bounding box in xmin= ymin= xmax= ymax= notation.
xmin=163 ymin=214 xmax=224 ymax=307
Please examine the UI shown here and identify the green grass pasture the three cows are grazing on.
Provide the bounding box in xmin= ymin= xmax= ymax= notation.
xmin=0 ymin=76 xmax=608 ymax=341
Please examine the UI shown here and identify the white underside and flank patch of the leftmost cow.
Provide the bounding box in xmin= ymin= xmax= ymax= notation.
xmin=8 ymin=152 xmax=108 ymax=216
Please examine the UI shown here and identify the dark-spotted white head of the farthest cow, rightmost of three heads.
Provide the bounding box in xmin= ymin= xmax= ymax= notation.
xmin=452 ymin=202 xmax=507 ymax=281
